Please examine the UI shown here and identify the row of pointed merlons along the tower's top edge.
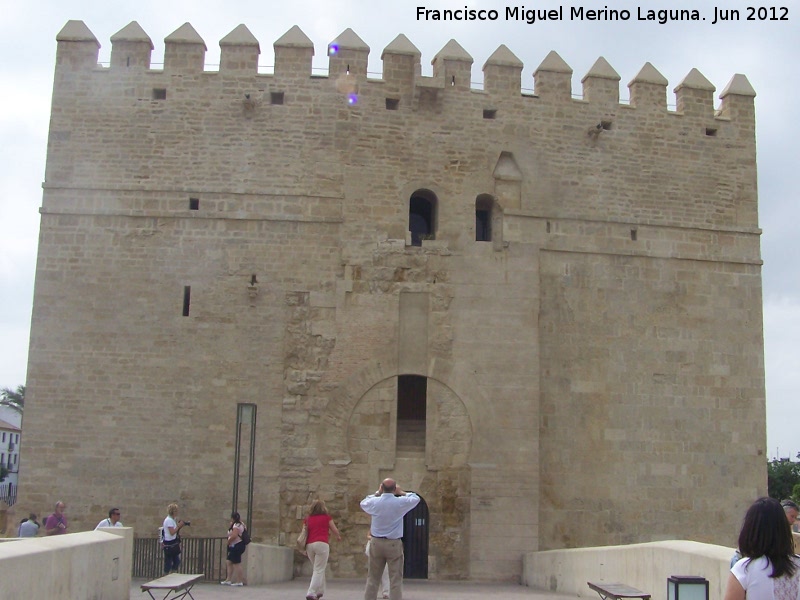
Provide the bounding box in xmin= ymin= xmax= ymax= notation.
xmin=56 ymin=21 xmax=756 ymax=121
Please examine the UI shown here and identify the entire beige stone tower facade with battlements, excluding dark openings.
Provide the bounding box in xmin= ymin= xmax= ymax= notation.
xmin=20 ymin=22 xmax=766 ymax=579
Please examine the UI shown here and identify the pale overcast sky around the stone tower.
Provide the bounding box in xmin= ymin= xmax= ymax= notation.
xmin=0 ymin=0 xmax=800 ymax=458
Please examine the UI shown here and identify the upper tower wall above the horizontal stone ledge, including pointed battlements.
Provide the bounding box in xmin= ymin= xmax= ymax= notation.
xmin=45 ymin=21 xmax=757 ymax=239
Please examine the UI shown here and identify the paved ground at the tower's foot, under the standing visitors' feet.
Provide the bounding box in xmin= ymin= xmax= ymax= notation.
xmin=131 ymin=579 xmax=575 ymax=600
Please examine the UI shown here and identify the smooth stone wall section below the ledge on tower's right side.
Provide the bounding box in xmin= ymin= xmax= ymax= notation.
xmin=540 ymin=252 xmax=764 ymax=549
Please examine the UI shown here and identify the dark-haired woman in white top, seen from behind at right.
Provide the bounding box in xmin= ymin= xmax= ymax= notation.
xmin=725 ymin=498 xmax=800 ymax=600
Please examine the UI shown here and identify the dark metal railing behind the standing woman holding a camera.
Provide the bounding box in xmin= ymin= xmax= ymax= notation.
xmin=131 ymin=537 xmax=227 ymax=581
